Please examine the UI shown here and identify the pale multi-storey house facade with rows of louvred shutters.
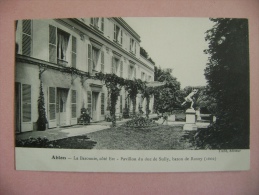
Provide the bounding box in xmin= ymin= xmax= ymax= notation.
xmin=15 ymin=18 xmax=154 ymax=133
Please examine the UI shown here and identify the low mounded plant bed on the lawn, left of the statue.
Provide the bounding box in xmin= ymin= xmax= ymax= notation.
xmin=124 ymin=115 xmax=158 ymax=128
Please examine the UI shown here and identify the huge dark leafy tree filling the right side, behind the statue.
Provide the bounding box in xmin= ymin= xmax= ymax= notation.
xmin=197 ymin=18 xmax=249 ymax=149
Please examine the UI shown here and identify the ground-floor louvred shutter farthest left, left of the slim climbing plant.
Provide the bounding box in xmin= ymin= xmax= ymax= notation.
xmin=22 ymin=84 xmax=31 ymax=122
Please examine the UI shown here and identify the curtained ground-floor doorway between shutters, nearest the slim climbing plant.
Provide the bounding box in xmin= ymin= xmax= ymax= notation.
xmin=56 ymin=88 xmax=68 ymax=126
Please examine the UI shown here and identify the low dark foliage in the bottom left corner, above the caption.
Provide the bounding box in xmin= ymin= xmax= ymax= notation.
xmin=15 ymin=137 xmax=59 ymax=148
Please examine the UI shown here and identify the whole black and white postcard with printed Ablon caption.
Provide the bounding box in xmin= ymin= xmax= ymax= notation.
xmin=14 ymin=17 xmax=250 ymax=172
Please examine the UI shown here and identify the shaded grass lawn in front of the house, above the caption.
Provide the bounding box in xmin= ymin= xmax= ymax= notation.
xmin=50 ymin=125 xmax=197 ymax=150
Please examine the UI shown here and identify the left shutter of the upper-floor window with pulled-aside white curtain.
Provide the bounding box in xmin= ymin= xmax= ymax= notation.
xmin=49 ymin=25 xmax=57 ymax=63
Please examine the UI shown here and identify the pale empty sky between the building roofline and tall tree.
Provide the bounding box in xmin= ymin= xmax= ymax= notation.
xmin=123 ymin=17 xmax=213 ymax=88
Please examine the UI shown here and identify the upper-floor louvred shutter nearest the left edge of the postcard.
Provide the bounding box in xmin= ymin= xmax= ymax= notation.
xmin=22 ymin=20 xmax=32 ymax=56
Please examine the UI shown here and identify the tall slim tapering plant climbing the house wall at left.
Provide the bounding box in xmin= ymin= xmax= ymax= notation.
xmin=37 ymin=79 xmax=48 ymax=131
